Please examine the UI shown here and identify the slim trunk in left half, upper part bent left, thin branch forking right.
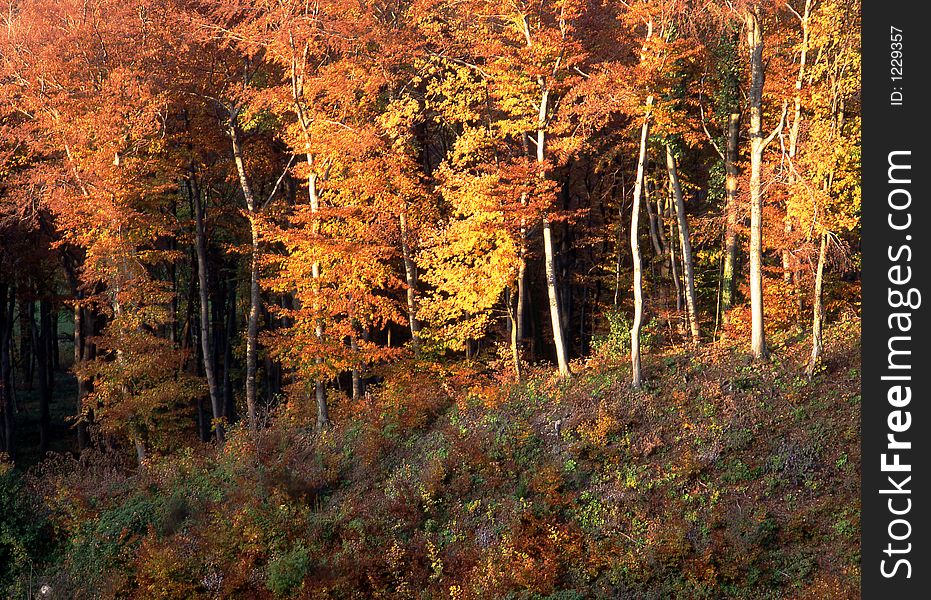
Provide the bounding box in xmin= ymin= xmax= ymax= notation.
xmin=229 ymin=124 xmax=262 ymax=429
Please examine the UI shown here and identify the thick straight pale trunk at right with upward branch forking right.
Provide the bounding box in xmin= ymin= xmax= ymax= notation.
xmin=746 ymin=6 xmax=785 ymax=360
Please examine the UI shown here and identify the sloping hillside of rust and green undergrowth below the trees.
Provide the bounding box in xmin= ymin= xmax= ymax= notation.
xmin=9 ymin=318 xmax=860 ymax=600
